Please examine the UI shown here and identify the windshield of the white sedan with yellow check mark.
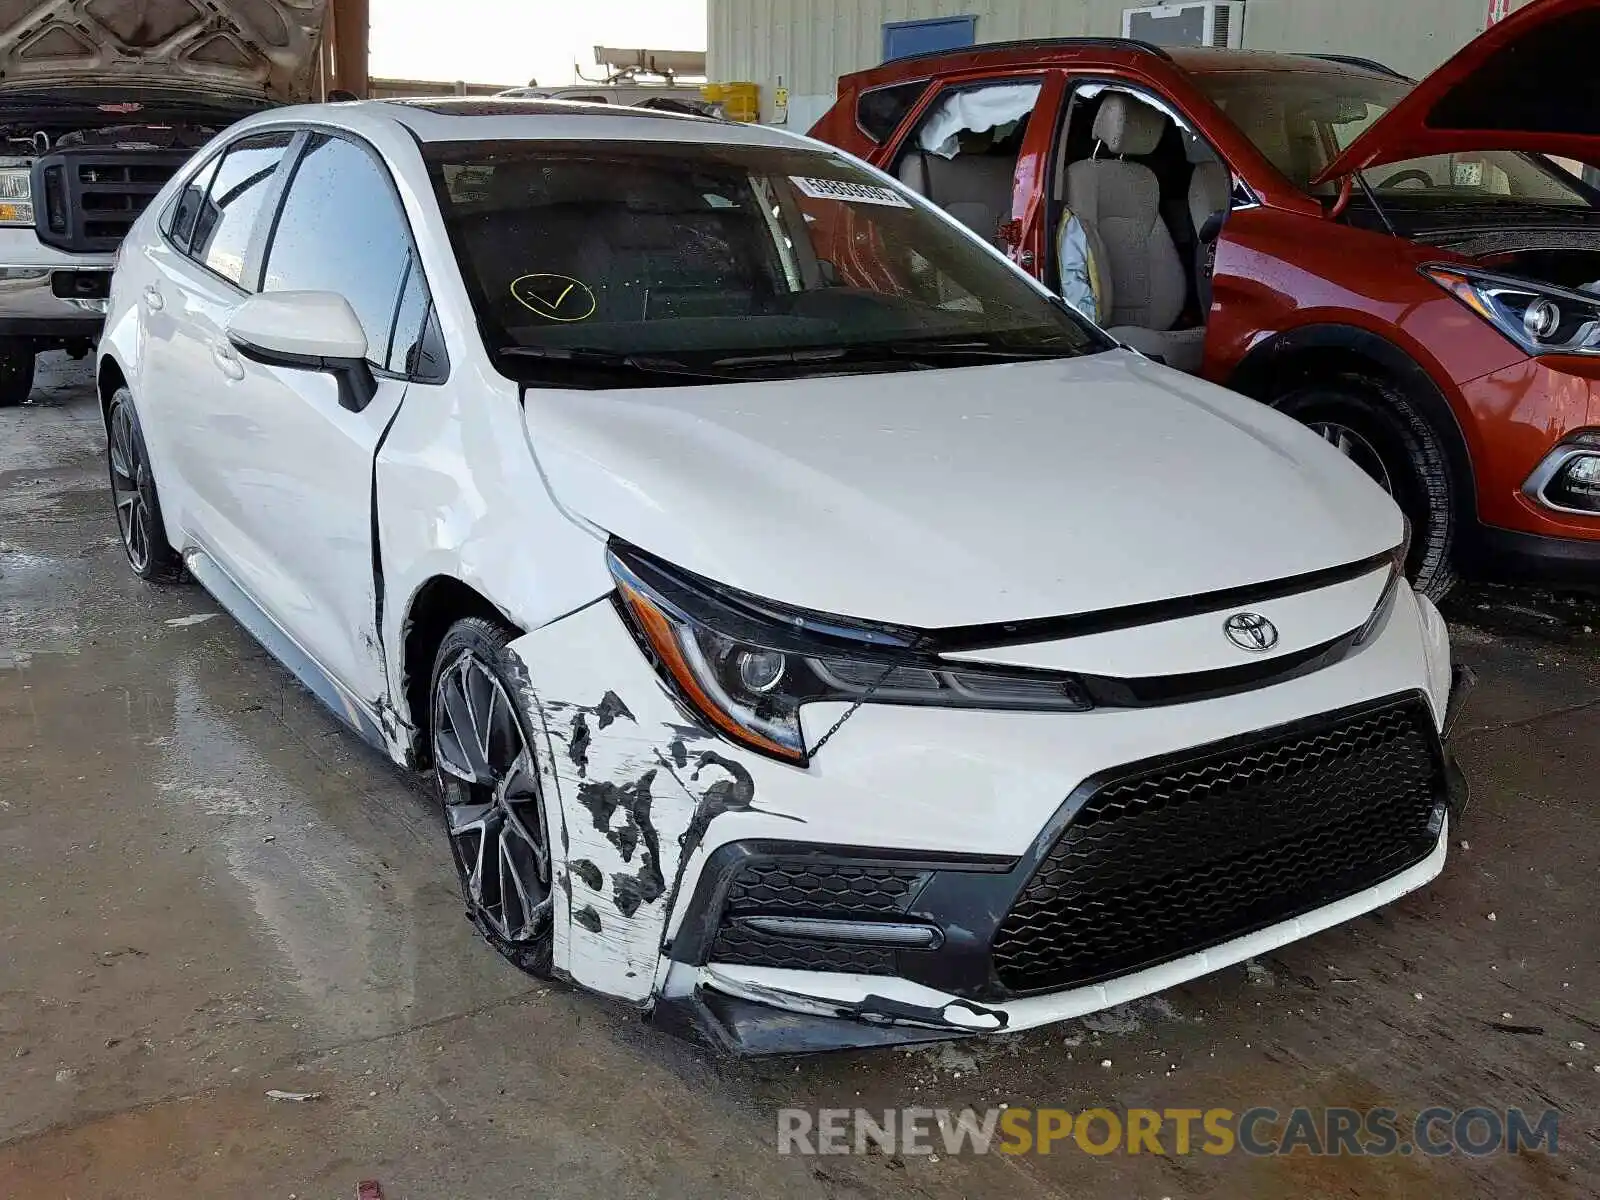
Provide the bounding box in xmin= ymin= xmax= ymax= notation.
xmin=427 ymin=142 xmax=1110 ymax=386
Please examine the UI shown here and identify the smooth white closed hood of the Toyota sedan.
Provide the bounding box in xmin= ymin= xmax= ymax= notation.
xmin=525 ymin=350 xmax=1403 ymax=629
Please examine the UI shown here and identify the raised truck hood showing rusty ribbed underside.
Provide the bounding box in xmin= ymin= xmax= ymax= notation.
xmin=0 ymin=0 xmax=330 ymax=102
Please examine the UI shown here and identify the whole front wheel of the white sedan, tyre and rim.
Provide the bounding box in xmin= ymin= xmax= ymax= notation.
xmin=429 ymin=618 xmax=555 ymax=979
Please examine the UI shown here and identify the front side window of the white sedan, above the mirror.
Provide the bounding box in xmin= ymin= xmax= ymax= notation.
xmin=261 ymin=136 xmax=421 ymax=366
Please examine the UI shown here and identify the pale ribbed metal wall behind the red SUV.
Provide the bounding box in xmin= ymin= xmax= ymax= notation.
xmin=707 ymin=0 xmax=1526 ymax=133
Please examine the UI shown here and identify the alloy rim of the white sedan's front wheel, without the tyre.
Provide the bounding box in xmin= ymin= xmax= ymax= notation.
xmin=434 ymin=650 xmax=550 ymax=942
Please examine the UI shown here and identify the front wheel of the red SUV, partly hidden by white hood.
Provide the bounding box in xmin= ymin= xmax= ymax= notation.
xmin=1272 ymin=374 xmax=1456 ymax=600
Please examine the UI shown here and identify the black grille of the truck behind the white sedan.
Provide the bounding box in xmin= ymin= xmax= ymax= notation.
xmin=34 ymin=150 xmax=190 ymax=254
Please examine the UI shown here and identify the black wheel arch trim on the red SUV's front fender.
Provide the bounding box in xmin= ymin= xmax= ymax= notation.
xmin=1227 ymin=329 xmax=1478 ymax=530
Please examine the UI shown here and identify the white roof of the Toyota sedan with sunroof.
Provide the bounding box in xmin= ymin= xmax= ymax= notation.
xmin=270 ymin=96 xmax=812 ymax=152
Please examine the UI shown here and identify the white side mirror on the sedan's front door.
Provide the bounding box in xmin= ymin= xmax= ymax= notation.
xmin=227 ymin=291 xmax=378 ymax=413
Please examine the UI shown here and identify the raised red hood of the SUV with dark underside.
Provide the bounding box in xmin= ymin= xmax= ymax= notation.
xmin=1312 ymin=0 xmax=1600 ymax=184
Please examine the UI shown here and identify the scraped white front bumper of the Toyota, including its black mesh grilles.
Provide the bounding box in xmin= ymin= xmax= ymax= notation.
xmin=510 ymin=592 xmax=1464 ymax=1054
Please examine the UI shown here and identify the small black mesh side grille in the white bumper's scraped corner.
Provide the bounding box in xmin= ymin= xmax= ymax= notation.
xmin=709 ymin=856 xmax=928 ymax=974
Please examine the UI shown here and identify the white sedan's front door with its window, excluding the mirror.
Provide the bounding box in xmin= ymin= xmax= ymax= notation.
xmin=206 ymin=133 xmax=429 ymax=706
